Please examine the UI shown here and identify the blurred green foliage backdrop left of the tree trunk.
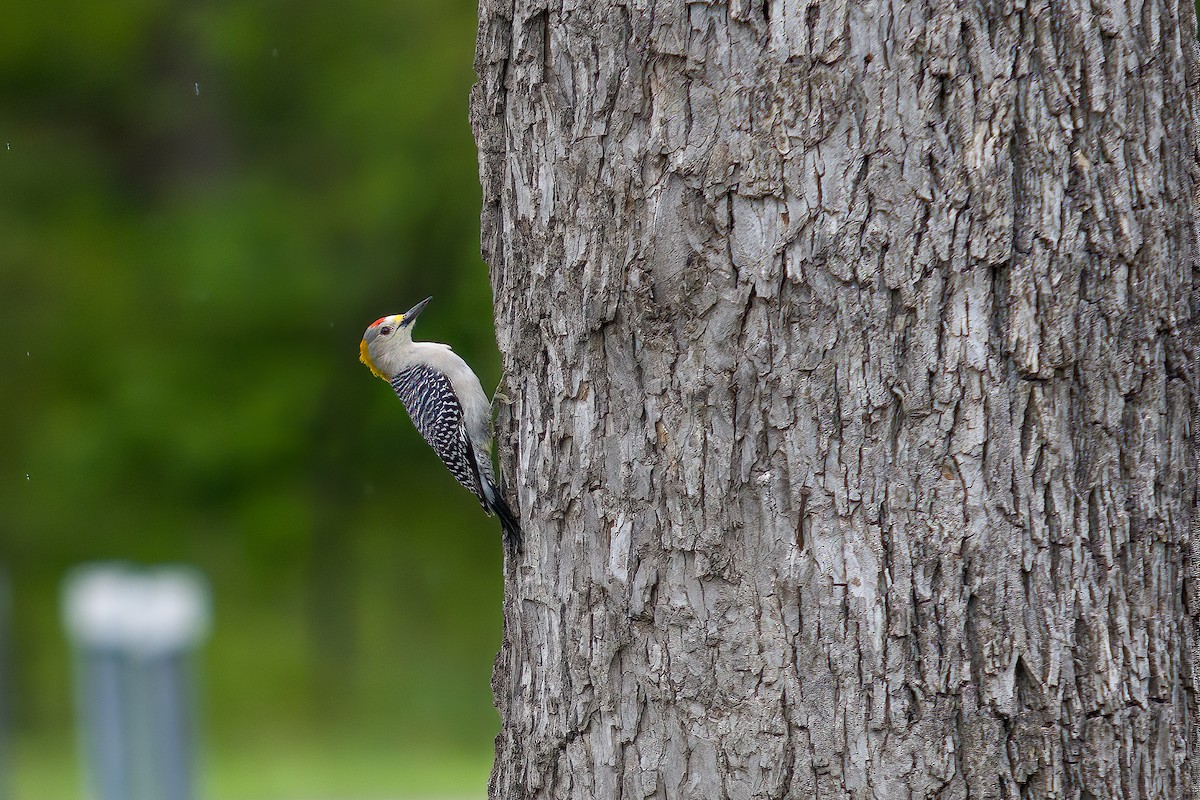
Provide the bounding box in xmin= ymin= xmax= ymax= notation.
xmin=0 ymin=0 xmax=500 ymax=798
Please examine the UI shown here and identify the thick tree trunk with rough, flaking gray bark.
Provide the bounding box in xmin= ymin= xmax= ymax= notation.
xmin=472 ymin=0 xmax=1198 ymax=800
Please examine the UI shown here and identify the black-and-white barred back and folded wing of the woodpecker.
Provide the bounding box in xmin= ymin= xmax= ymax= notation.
xmin=391 ymin=365 xmax=492 ymax=513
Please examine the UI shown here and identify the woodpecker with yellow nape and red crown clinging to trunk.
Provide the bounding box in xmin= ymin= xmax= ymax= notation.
xmin=359 ymin=297 xmax=521 ymax=553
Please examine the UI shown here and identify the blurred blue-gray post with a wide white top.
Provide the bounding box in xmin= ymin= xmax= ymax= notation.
xmin=64 ymin=565 xmax=209 ymax=800
